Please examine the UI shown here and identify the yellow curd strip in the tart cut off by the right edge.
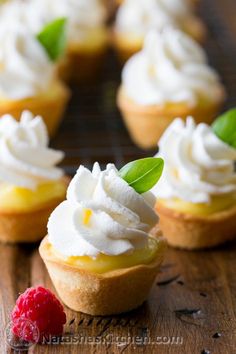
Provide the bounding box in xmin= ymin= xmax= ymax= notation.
xmin=158 ymin=193 xmax=236 ymax=216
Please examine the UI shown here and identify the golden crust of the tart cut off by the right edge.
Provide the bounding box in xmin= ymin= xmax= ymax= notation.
xmin=156 ymin=202 xmax=236 ymax=250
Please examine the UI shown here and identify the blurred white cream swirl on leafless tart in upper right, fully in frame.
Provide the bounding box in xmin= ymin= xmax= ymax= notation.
xmin=122 ymin=28 xmax=224 ymax=106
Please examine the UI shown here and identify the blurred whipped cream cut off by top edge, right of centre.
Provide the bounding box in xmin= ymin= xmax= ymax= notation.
xmin=115 ymin=0 xmax=192 ymax=37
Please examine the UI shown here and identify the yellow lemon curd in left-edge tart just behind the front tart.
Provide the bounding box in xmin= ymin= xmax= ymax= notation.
xmin=0 ymin=180 xmax=67 ymax=212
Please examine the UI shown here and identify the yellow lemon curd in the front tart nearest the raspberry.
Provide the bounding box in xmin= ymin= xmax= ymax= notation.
xmin=47 ymin=237 xmax=165 ymax=273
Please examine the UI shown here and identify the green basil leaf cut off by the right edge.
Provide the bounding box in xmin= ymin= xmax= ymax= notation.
xmin=212 ymin=108 xmax=236 ymax=148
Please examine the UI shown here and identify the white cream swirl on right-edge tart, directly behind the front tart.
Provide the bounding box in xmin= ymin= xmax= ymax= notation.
xmin=152 ymin=117 xmax=236 ymax=203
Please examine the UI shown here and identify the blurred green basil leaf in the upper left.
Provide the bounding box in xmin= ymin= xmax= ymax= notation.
xmin=37 ymin=17 xmax=67 ymax=61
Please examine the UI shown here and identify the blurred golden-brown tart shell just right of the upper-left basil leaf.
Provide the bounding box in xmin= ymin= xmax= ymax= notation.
xmin=58 ymin=28 xmax=109 ymax=83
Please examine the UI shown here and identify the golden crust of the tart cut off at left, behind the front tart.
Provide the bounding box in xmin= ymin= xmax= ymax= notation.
xmin=0 ymin=177 xmax=70 ymax=243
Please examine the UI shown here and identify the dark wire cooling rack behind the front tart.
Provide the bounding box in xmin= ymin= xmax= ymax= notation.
xmin=52 ymin=0 xmax=236 ymax=174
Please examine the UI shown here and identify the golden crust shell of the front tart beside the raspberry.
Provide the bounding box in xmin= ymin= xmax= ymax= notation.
xmin=39 ymin=235 xmax=166 ymax=316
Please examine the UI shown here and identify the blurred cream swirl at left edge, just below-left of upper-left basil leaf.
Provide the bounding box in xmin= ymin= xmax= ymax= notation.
xmin=0 ymin=21 xmax=54 ymax=100
